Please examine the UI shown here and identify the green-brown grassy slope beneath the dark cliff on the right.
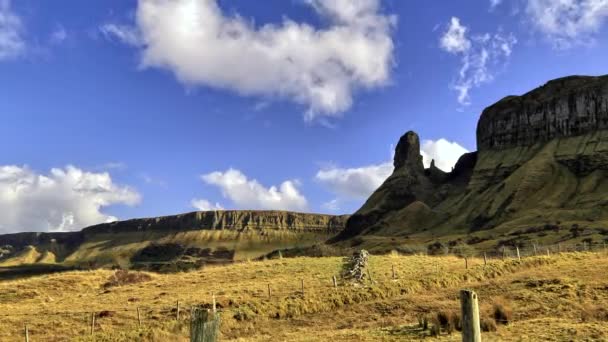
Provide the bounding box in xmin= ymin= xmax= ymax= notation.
xmin=346 ymin=131 xmax=608 ymax=249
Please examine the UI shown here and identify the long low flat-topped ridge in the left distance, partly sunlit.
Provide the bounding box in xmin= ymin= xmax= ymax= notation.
xmin=0 ymin=210 xmax=348 ymax=267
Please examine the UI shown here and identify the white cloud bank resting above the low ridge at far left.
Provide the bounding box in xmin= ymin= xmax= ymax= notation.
xmin=0 ymin=165 xmax=140 ymax=233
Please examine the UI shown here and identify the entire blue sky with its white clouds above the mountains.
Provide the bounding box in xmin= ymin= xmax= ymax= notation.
xmin=0 ymin=0 xmax=608 ymax=232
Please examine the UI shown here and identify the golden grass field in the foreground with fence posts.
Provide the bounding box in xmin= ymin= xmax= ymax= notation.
xmin=0 ymin=252 xmax=608 ymax=341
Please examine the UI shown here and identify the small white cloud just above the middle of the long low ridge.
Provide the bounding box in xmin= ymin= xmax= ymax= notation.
xmin=201 ymin=168 xmax=308 ymax=211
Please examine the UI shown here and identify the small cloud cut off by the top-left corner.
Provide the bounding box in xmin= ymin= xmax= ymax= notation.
xmin=0 ymin=0 xmax=26 ymax=60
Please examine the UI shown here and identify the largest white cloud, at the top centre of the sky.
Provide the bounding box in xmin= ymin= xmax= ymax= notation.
xmin=102 ymin=0 xmax=396 ymax=121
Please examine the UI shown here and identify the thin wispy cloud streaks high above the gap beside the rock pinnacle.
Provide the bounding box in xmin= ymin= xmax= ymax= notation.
xmin=439 ymin=17 xmax=517 ymax=105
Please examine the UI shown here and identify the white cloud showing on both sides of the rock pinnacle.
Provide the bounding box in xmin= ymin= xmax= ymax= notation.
xmin=315 ymin=138 xmax=468 ymax=200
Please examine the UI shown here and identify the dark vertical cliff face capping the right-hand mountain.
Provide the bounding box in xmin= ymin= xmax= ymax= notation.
xmin=477 ymin=76 xmax=608 ymax=151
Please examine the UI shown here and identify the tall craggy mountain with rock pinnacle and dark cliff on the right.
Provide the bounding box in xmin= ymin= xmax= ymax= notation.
xmin=333 ymin=76 xmax=608 ymax=249
